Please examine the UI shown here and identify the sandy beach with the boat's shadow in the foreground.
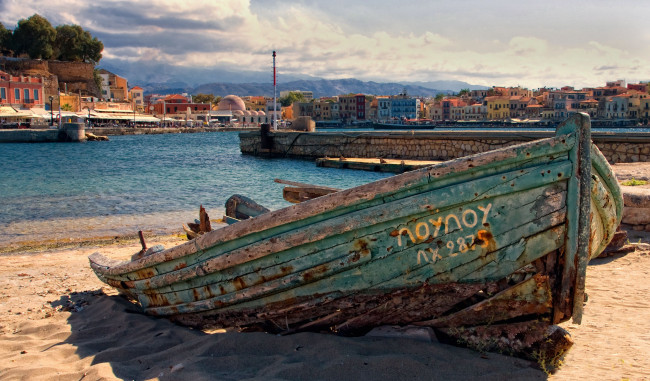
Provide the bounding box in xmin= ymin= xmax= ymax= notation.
xmin=0 ymin=163 xmax=650 ymax=381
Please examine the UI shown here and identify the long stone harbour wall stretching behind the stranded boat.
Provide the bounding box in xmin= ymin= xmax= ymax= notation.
xmin=239 ymin=131 xmax=650 ymax=163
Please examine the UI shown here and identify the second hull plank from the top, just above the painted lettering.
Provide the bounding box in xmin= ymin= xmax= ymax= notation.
xmin=98 ymin=157 xmax=571 ymax=288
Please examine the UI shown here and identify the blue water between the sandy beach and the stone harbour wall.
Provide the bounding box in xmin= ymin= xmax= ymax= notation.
xmin=0 ymin=132 xmax=388 ymax=244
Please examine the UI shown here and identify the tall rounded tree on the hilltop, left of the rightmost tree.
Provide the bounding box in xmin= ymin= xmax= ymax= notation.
xmin=12 ymin=14 xmax=56 ymax=59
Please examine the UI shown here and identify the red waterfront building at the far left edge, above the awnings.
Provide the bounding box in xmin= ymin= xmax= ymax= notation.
xmin=0 ymin=71 xmax=45 ymax=109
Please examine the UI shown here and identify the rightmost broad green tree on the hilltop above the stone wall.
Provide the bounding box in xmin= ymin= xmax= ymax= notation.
xmin=54 ymin=25 xmax=104 ymax=64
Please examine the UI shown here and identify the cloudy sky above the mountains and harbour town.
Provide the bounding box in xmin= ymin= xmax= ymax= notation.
xmin=0 ymin=0 xmax=650 ymax=88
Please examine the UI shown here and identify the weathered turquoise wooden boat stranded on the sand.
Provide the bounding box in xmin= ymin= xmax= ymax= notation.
xmin=90 ymin=114 xmax=622 ymax=360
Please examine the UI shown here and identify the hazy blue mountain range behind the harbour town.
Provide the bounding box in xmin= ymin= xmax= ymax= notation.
xmin=99 ymin=59 xmax=485 ymax=98
